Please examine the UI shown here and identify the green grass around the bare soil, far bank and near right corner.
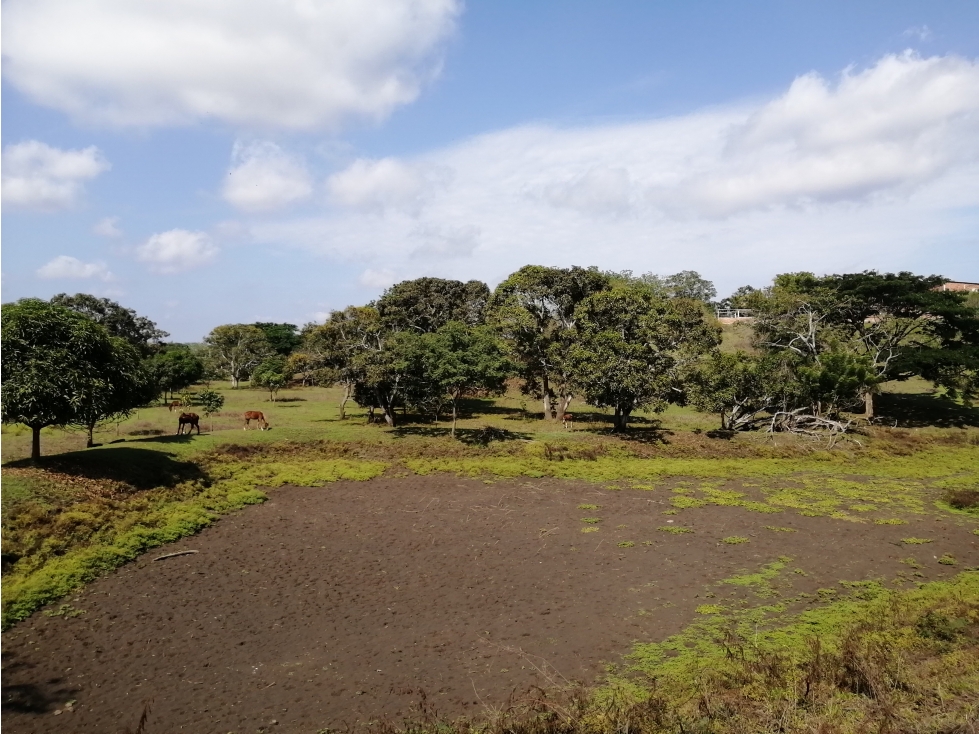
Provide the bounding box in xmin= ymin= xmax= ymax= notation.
xmin=2 ymin=381 xmax=979 ymax=732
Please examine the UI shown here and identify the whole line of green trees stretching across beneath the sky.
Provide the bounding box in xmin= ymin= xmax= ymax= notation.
xmin=3 ymin=265 xmax=979 ymax=455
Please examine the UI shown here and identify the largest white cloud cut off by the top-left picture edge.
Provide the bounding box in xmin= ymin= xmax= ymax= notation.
xmin=3 ymin=0 xmax=461 ymax=129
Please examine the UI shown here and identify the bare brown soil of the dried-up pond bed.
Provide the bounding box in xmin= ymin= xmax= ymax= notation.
xmin=3 ymin=476 xmax=979 ymax=734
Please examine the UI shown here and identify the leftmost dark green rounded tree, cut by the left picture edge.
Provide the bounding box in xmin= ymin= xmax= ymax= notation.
xmin=2 ymin=299 xmax=150 ymax=459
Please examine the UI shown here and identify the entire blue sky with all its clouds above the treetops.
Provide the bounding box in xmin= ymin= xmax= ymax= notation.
xmin=2 ymin=0 xmax=979 ymax=341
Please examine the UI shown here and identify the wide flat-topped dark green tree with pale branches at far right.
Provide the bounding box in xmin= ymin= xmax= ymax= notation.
xmin=751 ymin=271 xmax=979 ymax=416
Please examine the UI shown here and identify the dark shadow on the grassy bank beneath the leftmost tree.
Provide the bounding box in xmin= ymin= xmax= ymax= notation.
xmin=6 ymin=446 xmax=208 ymax=490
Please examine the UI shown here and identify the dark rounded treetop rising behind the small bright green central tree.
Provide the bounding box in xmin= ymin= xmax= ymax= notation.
xmin=374 ymin=278 xmax=490 ymax=334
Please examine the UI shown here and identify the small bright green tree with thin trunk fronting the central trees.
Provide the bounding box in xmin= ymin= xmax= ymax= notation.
xmin=422 ymin=321 xmax=512 ymax=437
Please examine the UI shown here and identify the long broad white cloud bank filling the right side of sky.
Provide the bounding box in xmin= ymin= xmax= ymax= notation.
xmin=251 ymin=54 xmax=979 ymax=300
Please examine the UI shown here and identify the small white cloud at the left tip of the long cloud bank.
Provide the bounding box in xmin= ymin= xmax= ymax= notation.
xmin=326 ymin=158 xmax=437 ymax=214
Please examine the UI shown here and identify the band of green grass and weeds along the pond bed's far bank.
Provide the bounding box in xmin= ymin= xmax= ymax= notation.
xmin=3 ymin=380 xmax=979 ymax=625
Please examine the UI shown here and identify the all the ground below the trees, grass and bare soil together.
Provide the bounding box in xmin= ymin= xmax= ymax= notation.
xmin=3 ymin=382 xmax=979 ymax=732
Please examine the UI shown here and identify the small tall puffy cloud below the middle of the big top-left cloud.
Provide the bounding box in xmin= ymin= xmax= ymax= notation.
xmin=222 ymin=142 xmax=313 ymax=212
